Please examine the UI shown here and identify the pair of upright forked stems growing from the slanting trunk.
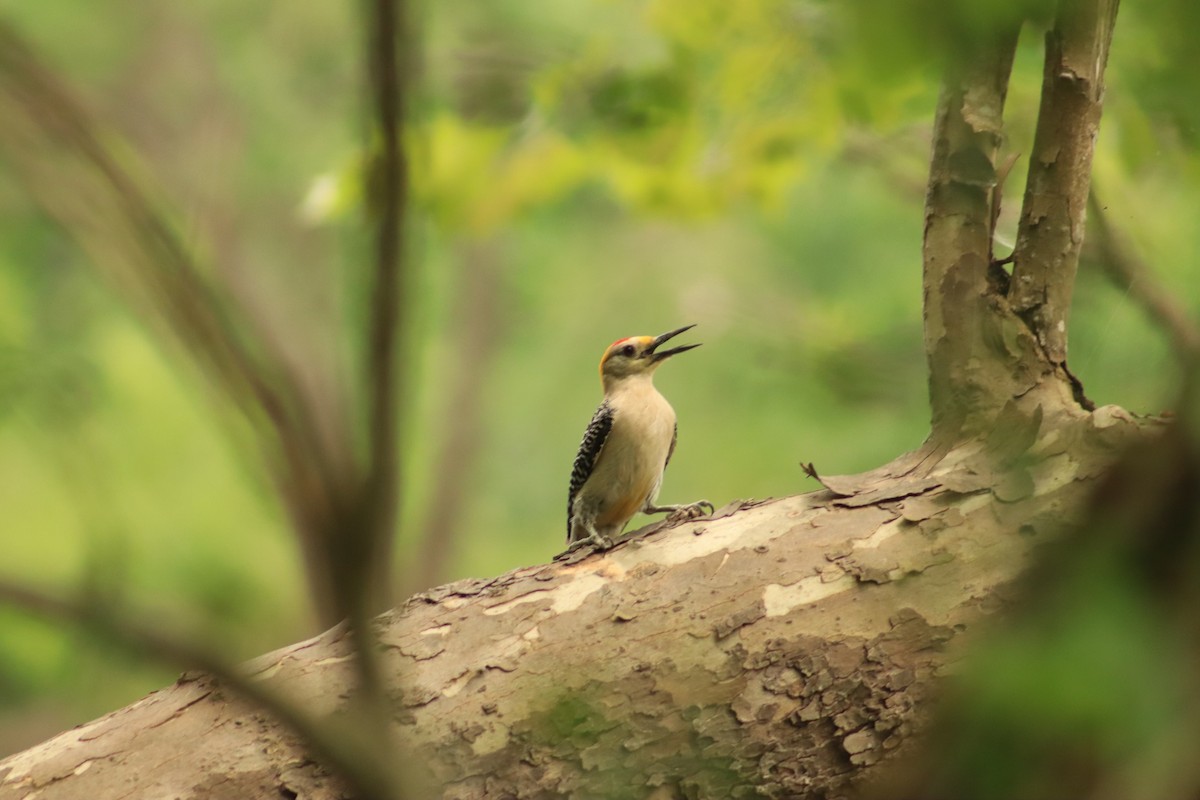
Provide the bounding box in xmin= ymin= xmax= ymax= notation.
xmin=923 ymin=0 xmax=1117 ymax=445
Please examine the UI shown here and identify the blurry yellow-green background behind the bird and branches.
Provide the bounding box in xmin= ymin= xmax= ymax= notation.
xmin=0 ymin=0 xmax=1200 ymax=754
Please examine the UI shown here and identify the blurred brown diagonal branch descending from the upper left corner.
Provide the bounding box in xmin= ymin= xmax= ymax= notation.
xmin=0 ymin=17 xmax=355 ymax=622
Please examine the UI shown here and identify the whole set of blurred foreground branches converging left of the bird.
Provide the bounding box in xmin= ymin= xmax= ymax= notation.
xmin=0 ymin=0 xmax=417 ymax=800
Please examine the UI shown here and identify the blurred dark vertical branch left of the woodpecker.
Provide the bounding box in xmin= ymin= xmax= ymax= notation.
xmin=325 ymin=0 xmax=409 ymax=765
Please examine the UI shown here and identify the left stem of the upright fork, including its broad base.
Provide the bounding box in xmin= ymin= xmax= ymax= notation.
xmin=924 ymin=30 xmax=1111 ymax=449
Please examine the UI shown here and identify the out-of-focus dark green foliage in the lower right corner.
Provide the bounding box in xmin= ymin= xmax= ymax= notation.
xmin=931 ymin=549 xmax=1194 ymax=800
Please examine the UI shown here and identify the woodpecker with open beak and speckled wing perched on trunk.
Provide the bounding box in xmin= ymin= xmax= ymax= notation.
xmin=566 ymin=325 xmax=713 ymax=549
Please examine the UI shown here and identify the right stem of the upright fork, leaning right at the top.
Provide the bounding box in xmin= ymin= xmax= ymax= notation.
xmin=1008 ymin=0 xmax=1118 ymax=365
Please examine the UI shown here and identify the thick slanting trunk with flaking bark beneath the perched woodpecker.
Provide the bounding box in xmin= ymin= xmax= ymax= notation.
xmin=0 ymin=408 xmax=1142 ymax=800
